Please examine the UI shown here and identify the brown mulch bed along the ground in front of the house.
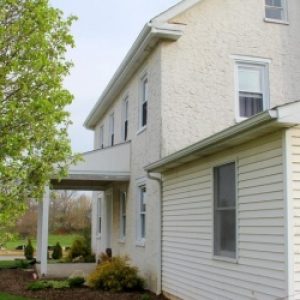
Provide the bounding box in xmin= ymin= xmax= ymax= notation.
xmin=0 ymin=270 xmax=165 ymax=300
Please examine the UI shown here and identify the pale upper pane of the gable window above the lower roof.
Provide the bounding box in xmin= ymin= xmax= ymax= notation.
xmin=239 ymin=66 xmax=262 ymax=93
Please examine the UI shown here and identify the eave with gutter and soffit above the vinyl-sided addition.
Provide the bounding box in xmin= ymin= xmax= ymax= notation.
xmin=145 ymin=101 xmax=300 ymax=173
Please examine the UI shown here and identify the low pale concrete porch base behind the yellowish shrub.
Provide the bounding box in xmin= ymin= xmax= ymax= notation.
xmin=36 ymin=263 xmax=96 ymax=278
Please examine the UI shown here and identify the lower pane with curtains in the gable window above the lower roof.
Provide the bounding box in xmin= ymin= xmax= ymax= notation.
xmin=239 ymin=92 xmax=263 ymax=117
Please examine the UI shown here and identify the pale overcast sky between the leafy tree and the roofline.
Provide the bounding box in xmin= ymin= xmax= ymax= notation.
xmin=51 ymin=0 xmax=179 ymax=152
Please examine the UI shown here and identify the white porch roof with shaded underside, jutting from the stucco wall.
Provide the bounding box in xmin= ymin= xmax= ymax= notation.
xmin=51 ymin=142 xmax=131 ymax=191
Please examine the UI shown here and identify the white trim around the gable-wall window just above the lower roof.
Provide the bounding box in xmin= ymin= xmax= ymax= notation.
xmin=231 ymin=55 xmax=271 ymax=122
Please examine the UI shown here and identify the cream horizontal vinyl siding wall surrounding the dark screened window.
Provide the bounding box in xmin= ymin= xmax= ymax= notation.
xmin=162 ymin=133 xmax=287 ymax=300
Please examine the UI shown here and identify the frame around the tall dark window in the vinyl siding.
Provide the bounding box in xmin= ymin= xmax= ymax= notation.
xmin=211 ymin=159 xmax=239 ymax=263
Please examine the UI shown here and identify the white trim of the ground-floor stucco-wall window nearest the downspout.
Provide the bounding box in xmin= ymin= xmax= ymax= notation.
xmin=135 ymin=178 xmax=148 ymax=247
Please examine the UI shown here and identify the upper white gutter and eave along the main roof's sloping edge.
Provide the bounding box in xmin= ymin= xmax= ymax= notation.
xmin=84 ymin=22 xmax=184 ymax=129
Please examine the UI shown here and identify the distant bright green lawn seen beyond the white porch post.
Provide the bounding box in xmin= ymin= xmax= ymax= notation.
xmin=4 ymin=234 xmax=78 ymax=251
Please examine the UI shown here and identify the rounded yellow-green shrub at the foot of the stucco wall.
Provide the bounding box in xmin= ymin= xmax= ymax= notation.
xmin=88 ymin=257 xmax=144 ymax=292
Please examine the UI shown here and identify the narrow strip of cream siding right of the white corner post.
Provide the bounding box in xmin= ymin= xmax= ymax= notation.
xmin=289 ymin=127 xmax=300 ymax=300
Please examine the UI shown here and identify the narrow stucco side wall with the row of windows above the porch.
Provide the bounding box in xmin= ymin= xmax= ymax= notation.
xmin=94 ymin=46 xmax=161 ymax=291
